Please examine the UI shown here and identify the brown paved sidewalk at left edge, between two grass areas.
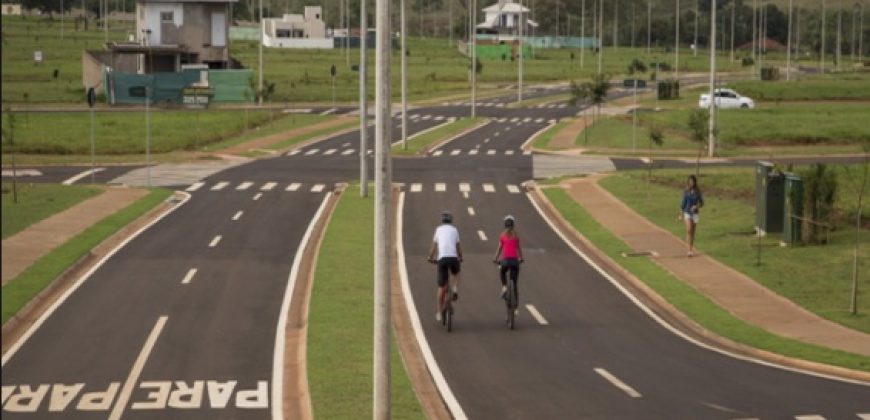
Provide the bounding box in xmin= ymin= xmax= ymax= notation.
xmin=2 ymin=187 xmax=148 ymax=285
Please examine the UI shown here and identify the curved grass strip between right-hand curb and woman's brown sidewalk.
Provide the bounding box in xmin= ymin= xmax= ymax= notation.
xmin=543 ymin=188 xmax=870 ymax=371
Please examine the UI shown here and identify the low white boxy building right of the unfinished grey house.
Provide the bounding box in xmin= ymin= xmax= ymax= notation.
xmin=262 ymin=6 xmax=334 ymax=49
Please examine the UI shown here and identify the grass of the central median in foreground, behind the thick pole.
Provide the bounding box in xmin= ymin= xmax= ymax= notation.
xmin=307 ymin=186 xmax=425 ymax=419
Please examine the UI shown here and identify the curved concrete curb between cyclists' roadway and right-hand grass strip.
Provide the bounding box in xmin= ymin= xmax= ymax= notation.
xmin=526 ymin=182 xmax=870 ymax=384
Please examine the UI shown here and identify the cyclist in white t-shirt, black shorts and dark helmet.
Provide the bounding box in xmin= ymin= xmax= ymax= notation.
xmin=428 ymin=211 xmax=462 ymax=322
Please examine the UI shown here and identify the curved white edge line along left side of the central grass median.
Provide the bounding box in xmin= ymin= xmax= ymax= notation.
xmin=272 ymin=192 xmax=332 ymax=419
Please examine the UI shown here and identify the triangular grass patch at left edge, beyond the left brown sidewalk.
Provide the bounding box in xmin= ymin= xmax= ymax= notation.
xmin=2 ymin=181 xmax=103 ymax=239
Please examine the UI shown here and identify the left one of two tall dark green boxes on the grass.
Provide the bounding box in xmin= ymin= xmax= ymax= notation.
xmin=755 ymin=162 xmax=785 ymax=236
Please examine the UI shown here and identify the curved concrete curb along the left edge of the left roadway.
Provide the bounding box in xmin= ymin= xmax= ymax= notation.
xmin=2 ymin=191 xmax=190 ymax=357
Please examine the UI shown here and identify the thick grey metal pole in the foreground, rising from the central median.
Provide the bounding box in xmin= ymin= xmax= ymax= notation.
xmin=372 ymin=0 xmax=393 ymax=414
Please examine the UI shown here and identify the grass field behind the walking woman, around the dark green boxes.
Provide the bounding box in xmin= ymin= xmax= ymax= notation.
xmin=600 ymin=166 xmax=870 ymax=333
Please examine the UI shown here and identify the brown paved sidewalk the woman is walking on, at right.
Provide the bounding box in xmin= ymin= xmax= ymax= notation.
xmin=562 ymin=176 xmax=870 ymax=356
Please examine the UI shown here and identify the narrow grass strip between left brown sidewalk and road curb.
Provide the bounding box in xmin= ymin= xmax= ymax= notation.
xmin=2 ymin=188 xmax=172 ymax=324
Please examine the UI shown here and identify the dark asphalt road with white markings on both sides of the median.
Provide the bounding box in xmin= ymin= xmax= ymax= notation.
xmin=2 ymin=88 xmax=870 ymax=419
